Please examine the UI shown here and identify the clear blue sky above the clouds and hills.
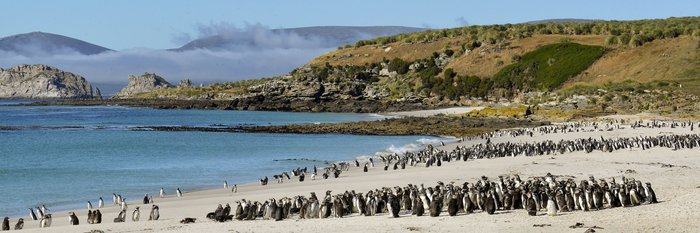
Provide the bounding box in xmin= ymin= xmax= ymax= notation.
xmin=0 ymin=0 xmax=700 ymax=50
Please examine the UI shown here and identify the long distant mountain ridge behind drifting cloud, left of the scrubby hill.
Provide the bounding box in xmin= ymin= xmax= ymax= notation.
xmin=172 ymin=26 xmax=427 ymax=51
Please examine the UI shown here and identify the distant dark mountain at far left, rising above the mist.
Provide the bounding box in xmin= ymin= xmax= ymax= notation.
xmin=0 ymin=32 xmax=112 ymax=56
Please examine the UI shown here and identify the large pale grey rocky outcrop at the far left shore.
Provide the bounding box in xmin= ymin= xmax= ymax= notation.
xmin=0 ymin=64 xmax=95 ymax=99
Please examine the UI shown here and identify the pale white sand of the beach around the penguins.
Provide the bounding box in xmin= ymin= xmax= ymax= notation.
xmin=11 ymin=123 xmax=700 ymax=232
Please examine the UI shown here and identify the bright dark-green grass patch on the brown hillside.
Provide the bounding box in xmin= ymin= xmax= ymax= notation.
xmin=493 ymin=42 xmax=605 ymax=91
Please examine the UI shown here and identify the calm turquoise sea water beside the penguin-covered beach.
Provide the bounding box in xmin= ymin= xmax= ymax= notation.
xmin=0 ymin=101 xmax=437 ymax=216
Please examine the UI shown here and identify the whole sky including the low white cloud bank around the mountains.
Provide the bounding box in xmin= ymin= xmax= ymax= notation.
xmin=0 ymin=0 xmax=700 ymax=89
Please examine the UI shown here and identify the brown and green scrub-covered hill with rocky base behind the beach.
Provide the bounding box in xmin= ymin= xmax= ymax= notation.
xmin=110 ymin=17 xmax=700 ymax=115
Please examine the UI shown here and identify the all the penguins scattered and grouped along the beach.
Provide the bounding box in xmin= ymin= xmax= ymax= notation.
xmin=2 ymin=120 xmax=684 ymax=230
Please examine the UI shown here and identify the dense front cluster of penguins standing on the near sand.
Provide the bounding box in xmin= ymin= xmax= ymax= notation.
xmin=206 ymin=173 xmax=658 ymax=222
